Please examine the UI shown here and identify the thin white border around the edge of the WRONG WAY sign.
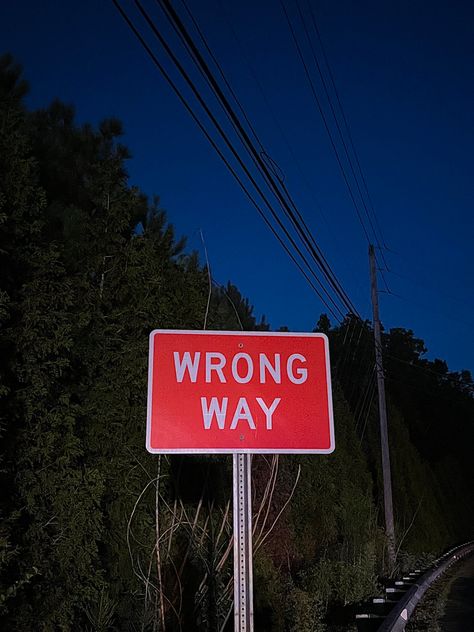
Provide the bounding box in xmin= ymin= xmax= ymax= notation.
xmin=146 ymin=329 xmax=336 ymax=454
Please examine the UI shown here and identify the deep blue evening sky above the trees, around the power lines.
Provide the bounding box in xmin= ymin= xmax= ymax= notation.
xmin=0 ymin=0 xmax=474 ymax=370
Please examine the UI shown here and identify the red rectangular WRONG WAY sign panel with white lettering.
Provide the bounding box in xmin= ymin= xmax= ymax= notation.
xmin=147 ymin=329 xmax=334 ymax=454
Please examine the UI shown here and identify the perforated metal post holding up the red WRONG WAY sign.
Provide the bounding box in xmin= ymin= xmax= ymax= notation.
xmin=233 ymin=454 xmax=253 ymax=632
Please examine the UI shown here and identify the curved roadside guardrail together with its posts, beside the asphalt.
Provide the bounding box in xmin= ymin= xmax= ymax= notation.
xmin=356 ymin=541 xmax=474 ymax=632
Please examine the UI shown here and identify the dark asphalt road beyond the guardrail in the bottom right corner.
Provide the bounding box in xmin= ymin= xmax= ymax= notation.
xmin=438 ymin=555 xmax=474 ymax=632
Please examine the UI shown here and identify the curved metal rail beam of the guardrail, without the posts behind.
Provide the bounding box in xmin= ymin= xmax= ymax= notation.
xmin=377 ymin=541 xmax=474 ymax=632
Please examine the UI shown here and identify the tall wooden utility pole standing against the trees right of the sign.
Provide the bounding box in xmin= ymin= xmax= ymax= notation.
xmin=369 ymin=245 xmax=395 ymax=570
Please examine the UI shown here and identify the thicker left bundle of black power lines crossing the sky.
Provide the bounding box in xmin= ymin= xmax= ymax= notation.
xmin=112 ymin=0 xmax=360 ymax=322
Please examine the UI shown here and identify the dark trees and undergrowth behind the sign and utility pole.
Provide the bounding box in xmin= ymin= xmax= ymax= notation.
xmin=0 ymin=56 xmax=474 ymax=632
